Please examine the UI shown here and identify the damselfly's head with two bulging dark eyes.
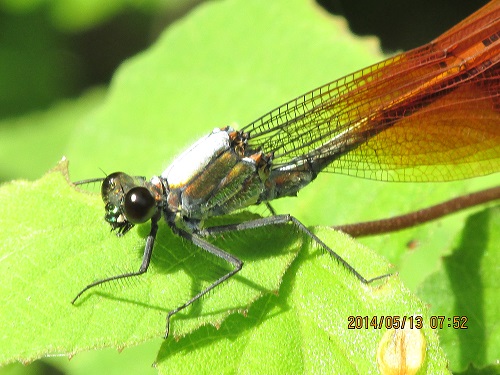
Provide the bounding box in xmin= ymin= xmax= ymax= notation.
xmin=101 ymin=172 xmax=157 ymax=235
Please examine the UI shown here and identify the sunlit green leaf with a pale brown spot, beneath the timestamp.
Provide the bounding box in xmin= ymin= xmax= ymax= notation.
xmin=158 ymin=226 xmax=447 ymax=374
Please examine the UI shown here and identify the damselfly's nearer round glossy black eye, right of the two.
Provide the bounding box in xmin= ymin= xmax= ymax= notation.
xmin=123 ymin=186 xmax=156 ymax=224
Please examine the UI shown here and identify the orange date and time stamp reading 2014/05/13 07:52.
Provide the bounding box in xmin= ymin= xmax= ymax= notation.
xmin=347 ymin=315 xmax=469 ymax=329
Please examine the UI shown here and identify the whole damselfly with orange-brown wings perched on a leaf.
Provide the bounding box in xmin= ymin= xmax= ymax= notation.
xmin=73 ymin=1 xmax=500 ymax=336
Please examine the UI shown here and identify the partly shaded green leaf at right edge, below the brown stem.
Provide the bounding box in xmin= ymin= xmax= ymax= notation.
xmin=419 ymin=207 xmax=500 ymax=371
